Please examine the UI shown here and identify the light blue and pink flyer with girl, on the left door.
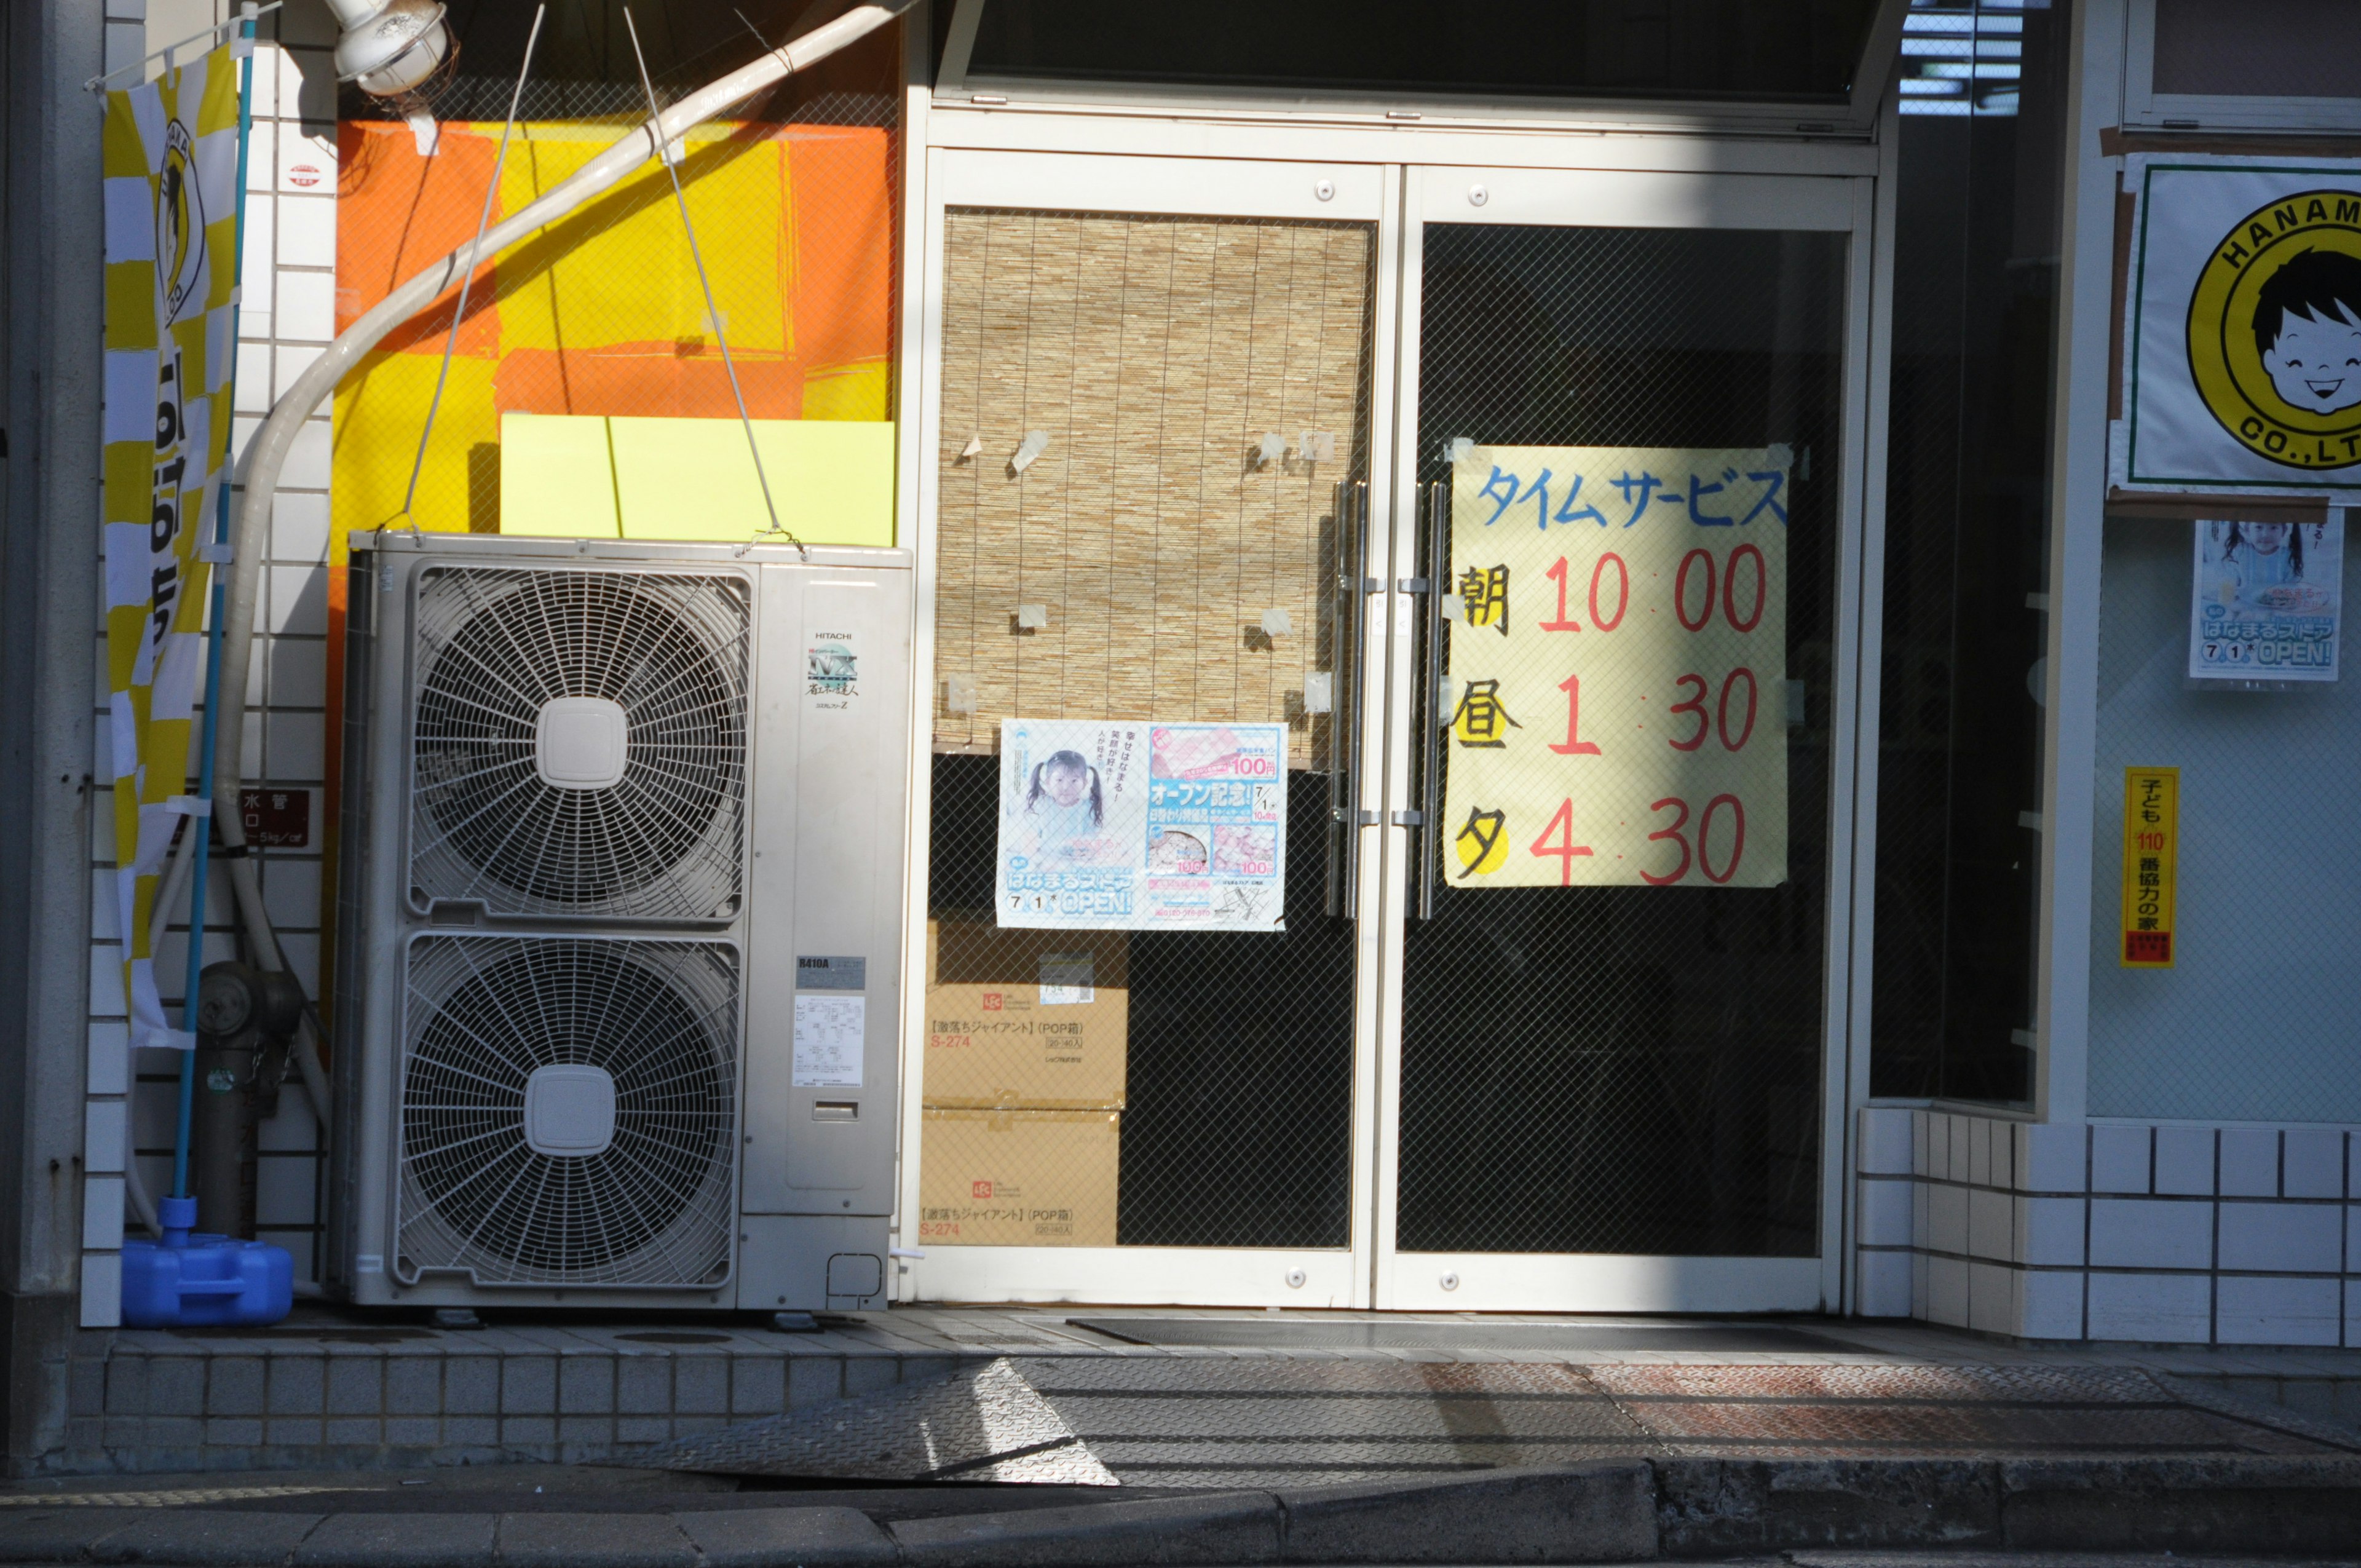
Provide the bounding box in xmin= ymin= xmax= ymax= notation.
xmin=994 ymin=718 xmax=1287 ymax=930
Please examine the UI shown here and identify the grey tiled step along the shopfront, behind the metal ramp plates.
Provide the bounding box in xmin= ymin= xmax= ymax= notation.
xmin=50 ymin=1309 xmax=2361 ymax=1473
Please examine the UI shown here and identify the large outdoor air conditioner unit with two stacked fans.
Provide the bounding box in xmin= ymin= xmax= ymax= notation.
xmin=328 ymin=531 xmax=911 ymax=1310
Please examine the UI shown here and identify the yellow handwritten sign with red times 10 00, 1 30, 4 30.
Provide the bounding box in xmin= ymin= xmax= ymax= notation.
xmin=1442 ymin=446 xmax=1790 ymax=888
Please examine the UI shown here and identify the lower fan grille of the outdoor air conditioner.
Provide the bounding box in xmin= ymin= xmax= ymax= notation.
xmin=390 ymin=935 xmax=739 ymax=1287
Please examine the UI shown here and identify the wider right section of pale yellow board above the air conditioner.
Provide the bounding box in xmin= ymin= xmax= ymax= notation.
xmin=609 ymin=418 xmax=893 ymax=545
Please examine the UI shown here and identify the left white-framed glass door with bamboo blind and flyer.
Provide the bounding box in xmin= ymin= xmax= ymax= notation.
xmin=902 ymin=151 xmax=1398 ymax=1306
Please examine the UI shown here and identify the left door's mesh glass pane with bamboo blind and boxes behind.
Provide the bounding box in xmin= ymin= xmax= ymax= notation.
xmin=921 ymin=210 xmax=1374 ymax=1247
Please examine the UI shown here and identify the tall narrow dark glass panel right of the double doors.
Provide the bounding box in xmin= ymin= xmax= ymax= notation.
xmin=1870 ymin=7 xmax=2068 ymax=1103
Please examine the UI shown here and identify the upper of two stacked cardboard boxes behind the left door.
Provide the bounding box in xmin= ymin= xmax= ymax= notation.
xmin=921 ymin=921 xmax=1131 ymax=1110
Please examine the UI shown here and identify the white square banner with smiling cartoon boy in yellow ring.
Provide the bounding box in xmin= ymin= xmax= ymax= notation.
xmin=2111 ymin=154 xmax=2361 ymax=496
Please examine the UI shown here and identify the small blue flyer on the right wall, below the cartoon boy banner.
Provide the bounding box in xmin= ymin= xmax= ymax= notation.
xmin=2189 ymin=508 xmax=2344 ymax=685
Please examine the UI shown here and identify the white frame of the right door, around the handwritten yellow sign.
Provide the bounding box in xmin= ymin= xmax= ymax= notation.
xmin=1372 ymin=165 xmax=1877 ymax=1313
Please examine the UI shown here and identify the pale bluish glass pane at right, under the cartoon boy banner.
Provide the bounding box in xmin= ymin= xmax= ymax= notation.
xmin=2087 ymin=512 xmax=2361 ymax=1124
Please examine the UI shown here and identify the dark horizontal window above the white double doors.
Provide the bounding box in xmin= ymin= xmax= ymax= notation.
xmin=968 ymin=0 xmax=1875 ymax=101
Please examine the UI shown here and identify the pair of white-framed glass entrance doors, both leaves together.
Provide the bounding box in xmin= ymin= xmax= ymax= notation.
xmin=900 ymin=149 xmax=1870 ymax=1310
